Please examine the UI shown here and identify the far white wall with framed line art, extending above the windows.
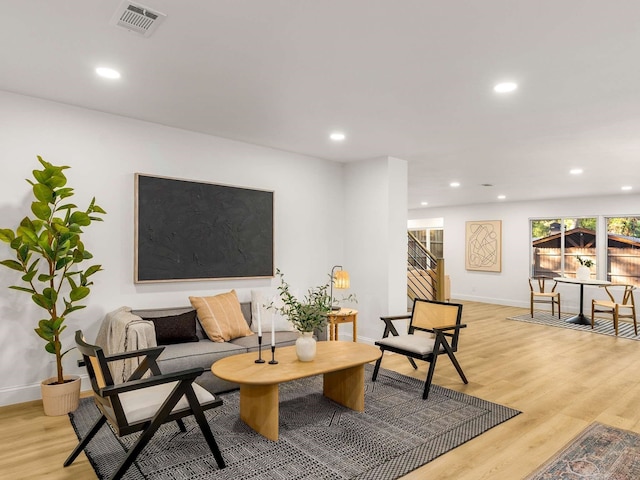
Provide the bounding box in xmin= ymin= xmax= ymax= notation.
xmin=409 ymin=195 xmax=640 ymax=313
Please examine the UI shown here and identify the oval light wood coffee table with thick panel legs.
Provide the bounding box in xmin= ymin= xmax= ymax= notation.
xmin=211 ymin=342 xmax=381 ymax=441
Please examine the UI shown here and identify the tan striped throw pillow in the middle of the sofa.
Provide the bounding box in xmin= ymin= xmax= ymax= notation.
xmin=189 ymin=290 xmax=253 ymax=342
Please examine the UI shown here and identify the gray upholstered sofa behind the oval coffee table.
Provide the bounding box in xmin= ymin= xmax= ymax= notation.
xmin=129 ymin=303 xmax=326 ymax=393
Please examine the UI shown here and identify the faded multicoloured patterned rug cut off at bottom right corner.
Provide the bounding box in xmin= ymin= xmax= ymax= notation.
xmin=525 ymin=423 xmax=640 ymax=480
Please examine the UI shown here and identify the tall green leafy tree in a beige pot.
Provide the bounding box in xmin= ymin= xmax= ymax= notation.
xmin=0 ymin=156 xmax=106 ymax=415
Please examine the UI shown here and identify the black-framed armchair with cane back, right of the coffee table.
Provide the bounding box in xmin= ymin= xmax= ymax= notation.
xmin=372 ymin=298 xmax=469 ymax=399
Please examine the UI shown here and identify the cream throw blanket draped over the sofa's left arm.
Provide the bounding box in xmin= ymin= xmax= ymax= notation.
xmin=96 ymin=307 xmax=157 ymax=384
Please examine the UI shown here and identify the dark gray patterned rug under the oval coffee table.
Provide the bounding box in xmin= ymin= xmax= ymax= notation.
xmin=69 ymin=365 xmax=520 ymax=480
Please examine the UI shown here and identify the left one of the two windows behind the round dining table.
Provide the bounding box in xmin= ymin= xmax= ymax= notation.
xmin=531 ymin=217 xmax=598 ymax=278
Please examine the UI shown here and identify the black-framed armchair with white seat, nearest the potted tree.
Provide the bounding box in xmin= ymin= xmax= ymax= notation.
xmin=64 ymin=330 xmax=225 ymax=479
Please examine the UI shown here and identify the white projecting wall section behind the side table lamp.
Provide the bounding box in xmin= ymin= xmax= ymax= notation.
xmin=344 ymin=157 xmax=408 ymax=343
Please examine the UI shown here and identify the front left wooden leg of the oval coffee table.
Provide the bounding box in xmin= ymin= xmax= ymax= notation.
xmin=240 ymin=383 xmax=280 ymax=442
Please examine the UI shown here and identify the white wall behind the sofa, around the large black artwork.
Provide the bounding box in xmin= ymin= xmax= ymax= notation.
xmin=0 ymin=92 xmax=356 ymax=405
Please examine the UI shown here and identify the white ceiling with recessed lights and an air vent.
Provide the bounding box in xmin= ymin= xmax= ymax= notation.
xmin=0 ymin=0 xmax=640 ymax=208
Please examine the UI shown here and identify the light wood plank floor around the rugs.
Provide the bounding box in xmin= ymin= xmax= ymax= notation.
xmin=0 ymin=302 xmax=640 ymax=480
